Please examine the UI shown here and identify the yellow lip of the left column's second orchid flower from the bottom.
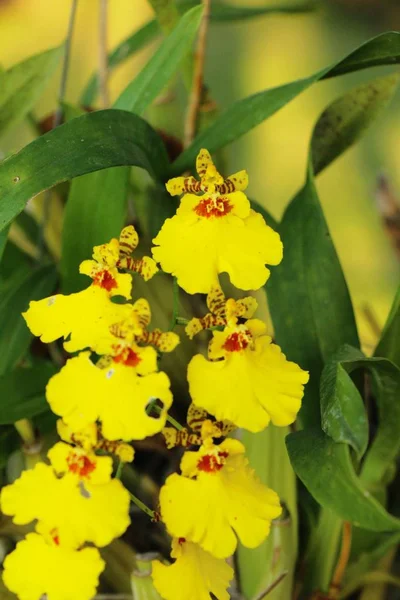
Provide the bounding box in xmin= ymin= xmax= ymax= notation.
xmin=1 ymin=450 xmax=130 ymax=549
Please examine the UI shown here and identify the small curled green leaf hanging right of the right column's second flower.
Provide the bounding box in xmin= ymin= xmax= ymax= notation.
xmin=321 ymin=346 xmax=368 ymax=458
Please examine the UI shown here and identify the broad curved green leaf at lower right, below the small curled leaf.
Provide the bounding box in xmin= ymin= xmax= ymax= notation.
xmin=286 ymin=429 xmax=400 ymax=531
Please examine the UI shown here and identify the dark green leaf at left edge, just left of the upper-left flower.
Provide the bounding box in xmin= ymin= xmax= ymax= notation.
xmin=0 ymin=266 xmax=57 ymax=375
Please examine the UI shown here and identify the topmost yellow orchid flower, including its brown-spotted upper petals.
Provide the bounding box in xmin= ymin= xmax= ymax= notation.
xmin=153 ymin=150 xmax=282 ymax=294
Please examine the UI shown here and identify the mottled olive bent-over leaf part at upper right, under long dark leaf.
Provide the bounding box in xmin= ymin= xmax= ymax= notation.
xmin=311 ymin=73 xmax=400 ymax=175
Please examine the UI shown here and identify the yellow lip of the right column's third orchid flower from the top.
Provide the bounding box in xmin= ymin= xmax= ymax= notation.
xmin=160 ymin=439 xmax=282 ymax=558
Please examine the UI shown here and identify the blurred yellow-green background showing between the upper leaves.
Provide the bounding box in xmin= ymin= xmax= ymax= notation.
xmin=0 ymin=0 xmax=400 ymax=351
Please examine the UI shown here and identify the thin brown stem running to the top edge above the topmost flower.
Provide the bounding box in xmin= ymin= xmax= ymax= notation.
xmin=184 ymin=0 xmax=211 ymax=148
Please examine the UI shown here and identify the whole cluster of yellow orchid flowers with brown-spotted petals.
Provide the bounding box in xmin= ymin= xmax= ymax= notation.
xmin=1 ymin=150 xmax=308 ymax=600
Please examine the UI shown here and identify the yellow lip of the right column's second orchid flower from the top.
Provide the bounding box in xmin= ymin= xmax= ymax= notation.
xmin=188 ymin=319 xmax=308 ymax=432
